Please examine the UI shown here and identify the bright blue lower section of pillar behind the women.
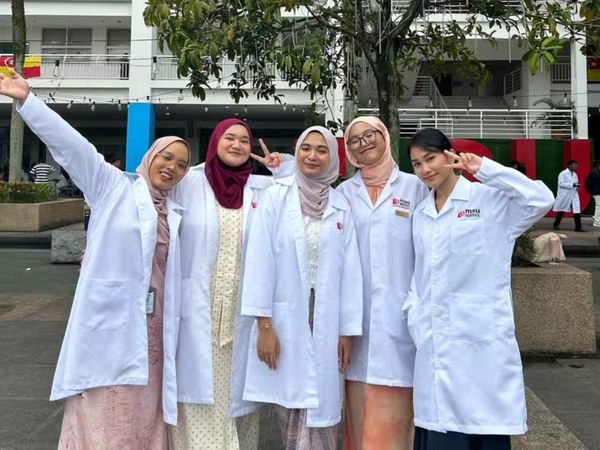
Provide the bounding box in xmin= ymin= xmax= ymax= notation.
xmin=125 ymin=103 xmax=156 ymax=172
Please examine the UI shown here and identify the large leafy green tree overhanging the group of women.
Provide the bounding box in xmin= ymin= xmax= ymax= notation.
xmin=144 ymin=0 xmax=600 ymax=159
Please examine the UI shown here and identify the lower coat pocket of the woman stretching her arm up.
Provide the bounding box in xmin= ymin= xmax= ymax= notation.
xmin=81 ymin=279 xmax=131 ymax=331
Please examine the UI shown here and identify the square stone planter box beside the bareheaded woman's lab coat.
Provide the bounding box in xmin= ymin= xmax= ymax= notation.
xmin=512 ymin=263 xmax=596 ymax=354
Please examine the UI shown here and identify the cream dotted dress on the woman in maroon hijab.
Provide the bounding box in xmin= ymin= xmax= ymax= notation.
xmin=169 ymin=203 xmax=259 ymax=450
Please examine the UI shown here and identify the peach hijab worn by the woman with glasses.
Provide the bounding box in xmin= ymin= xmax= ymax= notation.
xmin=344 ymin=116 xmax=397 ymax=204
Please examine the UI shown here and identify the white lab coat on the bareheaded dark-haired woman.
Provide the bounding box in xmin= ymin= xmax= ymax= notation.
xmin=405 ymin=158 xmax=554 ymax=435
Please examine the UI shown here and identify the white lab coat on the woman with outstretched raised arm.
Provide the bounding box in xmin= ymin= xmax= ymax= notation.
xmin=19 ymin=95 xmax=182 ymax=425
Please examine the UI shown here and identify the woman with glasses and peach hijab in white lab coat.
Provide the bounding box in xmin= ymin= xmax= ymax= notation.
xmin=338 ymin=116 xmax=427 ymax=450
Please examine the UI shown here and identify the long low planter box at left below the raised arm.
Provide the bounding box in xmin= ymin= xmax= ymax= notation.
xmin=0 ymin=198 xmax=83 ymax=231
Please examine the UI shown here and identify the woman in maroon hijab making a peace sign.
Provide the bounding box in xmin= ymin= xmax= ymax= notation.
xmin=169 ymin=119 xmax=293 ymax=450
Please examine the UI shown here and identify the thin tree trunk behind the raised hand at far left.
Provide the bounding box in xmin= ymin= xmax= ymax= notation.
xmin=8 ymin=0 xmax=27 ymax=181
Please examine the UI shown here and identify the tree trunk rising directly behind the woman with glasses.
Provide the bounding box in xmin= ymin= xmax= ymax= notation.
xmin=376 ymin=45 xmax=404 ymax=163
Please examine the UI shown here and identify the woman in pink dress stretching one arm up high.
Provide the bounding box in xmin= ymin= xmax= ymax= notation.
xmin=0 ymin=71 xmax=190 ymax=450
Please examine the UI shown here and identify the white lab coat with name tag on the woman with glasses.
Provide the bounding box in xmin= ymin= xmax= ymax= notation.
xmin=338 ymin=168 xmax=428 ymax=387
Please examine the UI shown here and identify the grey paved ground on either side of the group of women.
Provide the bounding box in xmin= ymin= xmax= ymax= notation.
xmin=0 ymin=227 xmax=600 ymax=450
